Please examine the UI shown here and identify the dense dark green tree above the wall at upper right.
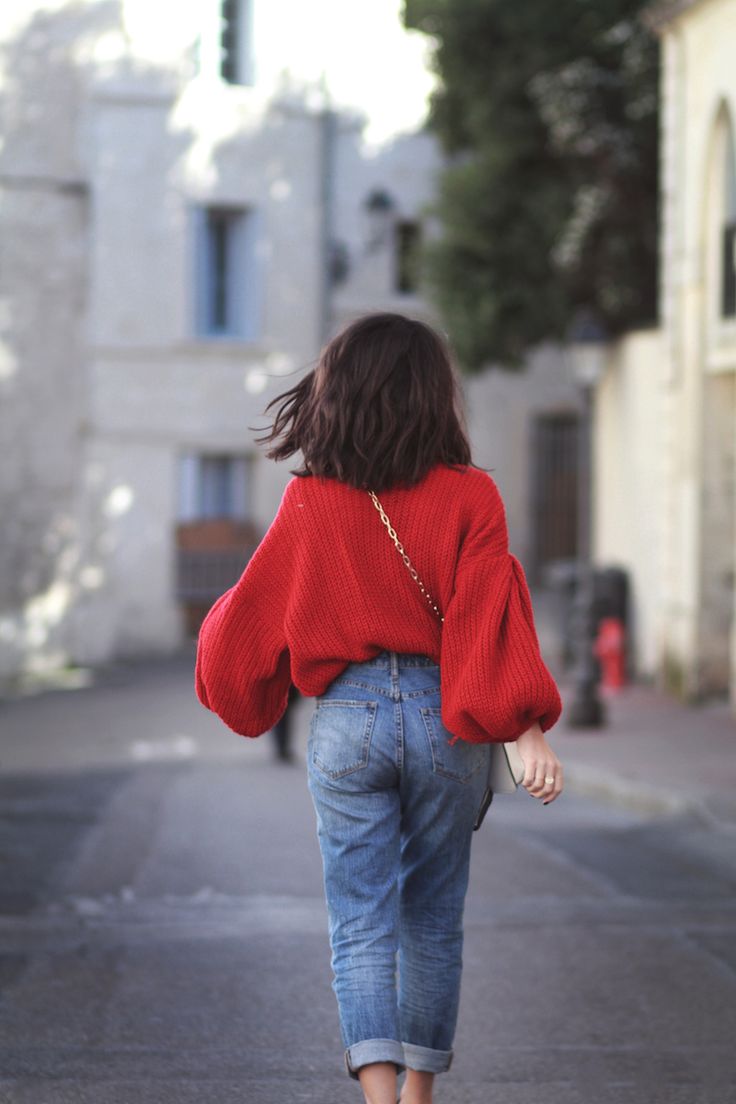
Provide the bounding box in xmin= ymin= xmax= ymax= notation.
xmin=404 ymin=0 xmax=659 ymax=372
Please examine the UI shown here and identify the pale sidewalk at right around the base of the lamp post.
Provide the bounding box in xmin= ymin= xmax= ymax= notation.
xmin=532 ymin=590 xmax=736 ymax=831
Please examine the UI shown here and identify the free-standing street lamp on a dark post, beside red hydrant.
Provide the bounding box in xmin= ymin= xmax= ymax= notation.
xmin=566 ymin=310 xmax=608 ymax=729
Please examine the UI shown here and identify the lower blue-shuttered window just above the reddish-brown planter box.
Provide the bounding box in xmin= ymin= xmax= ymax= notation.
xmin=179 ymin=453 xmax=250 ymax=521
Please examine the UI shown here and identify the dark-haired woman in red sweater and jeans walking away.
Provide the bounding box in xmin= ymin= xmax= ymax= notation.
xmin=195 ymin=314 xmax=563 ymax=1104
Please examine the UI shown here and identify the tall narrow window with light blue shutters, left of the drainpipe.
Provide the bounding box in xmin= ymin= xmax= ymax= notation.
xmin=195 ymin=208 xmax=256 ymax=339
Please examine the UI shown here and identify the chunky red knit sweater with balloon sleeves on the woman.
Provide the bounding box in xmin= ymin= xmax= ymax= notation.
xmin=195 ymin=465 xmax=562 ymax=743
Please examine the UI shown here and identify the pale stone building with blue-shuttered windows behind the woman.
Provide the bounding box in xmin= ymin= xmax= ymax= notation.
xmin=0 ymin=0 xmax=576 ymax=679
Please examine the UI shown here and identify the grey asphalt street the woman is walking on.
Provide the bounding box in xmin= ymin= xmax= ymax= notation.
xmin=0 ymin=654 xmax=736 ymax=1104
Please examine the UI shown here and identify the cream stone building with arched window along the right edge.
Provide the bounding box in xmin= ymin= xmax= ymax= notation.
xmin=595 ymin=0 xmax=736 ymax=708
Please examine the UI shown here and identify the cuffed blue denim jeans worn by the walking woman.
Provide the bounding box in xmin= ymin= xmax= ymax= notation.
xmin=307 ymin=651 xmax=490 ymax=1079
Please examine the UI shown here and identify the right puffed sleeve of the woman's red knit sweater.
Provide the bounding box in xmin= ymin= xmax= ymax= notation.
xmin=440 ymin=474 xmax=562 ymax=743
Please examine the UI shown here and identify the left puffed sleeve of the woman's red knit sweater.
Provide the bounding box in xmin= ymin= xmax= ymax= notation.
xmin=194 ymin=484 xmax=292 ymax=736
